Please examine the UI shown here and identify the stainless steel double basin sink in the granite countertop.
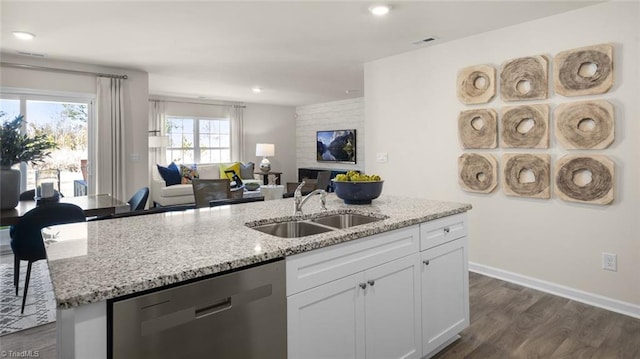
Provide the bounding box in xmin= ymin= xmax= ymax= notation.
xmin=251 ymin=213 xmax=384 ymax=238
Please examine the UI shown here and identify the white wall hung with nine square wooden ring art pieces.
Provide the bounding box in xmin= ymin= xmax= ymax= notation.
xmin=365 ymin=2 xmax=640 ymax=308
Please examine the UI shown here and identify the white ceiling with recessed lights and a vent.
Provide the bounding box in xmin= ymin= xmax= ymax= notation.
xmin=0 ymin=0 xmax=595 ymax=106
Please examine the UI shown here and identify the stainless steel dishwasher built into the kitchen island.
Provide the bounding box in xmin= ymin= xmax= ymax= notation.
xmin=110 ymin=260 xmax=287 ymax=359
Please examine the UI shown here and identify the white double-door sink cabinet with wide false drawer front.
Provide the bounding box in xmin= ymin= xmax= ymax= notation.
xmin=287 ymin=226 xmax=421 ymax=359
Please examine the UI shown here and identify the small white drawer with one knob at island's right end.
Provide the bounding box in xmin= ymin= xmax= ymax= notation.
xmin=420 ymin=213 xmax=467 ymax=251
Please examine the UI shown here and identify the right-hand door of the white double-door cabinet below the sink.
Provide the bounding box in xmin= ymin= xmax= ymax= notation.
xmin=365 ymin=253 xmax=422 ymax=359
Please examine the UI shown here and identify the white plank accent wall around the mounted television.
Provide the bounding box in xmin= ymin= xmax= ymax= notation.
xmin=296 ymin=97 xmax=366 ymax=170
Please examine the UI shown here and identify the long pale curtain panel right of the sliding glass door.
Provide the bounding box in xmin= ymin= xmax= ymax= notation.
xmin=96 ymin=77 xmax=128 ymax=202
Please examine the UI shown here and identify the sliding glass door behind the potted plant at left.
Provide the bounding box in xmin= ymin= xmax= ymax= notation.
xmin=0 ymin=93 xmax=95 ymax=197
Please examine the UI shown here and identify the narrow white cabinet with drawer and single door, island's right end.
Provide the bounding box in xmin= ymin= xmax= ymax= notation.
xmin=420 ymin=214 xmax=469 ymax=357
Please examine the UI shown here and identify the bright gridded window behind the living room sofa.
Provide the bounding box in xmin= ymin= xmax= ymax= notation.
xmin=167 ymin=116 xmax=231 ymax=163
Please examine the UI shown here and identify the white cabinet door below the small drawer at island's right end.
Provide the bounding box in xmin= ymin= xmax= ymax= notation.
xmin=421 ymin=237 xmax=469 ymax=356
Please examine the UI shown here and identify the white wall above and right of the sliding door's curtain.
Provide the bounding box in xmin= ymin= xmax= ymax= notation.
xmin=0 ymin=54 xmax=149 ymax=201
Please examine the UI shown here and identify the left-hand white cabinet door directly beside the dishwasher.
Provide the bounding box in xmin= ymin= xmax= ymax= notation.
xmin=287 ymin=272 xmax=365 ymax=359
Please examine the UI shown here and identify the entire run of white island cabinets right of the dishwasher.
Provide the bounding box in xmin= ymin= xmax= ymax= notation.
xmin=287 ymin=214 xmax=469 ymax=359
